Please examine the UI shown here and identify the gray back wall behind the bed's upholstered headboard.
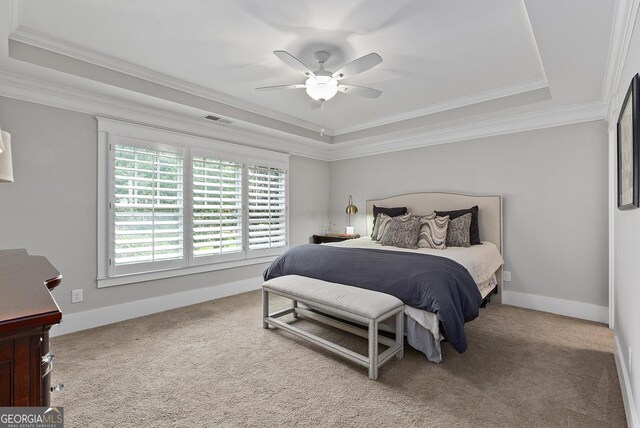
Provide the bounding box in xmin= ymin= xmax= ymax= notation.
xmin=330 ymin=121 xmax=608 ymax=306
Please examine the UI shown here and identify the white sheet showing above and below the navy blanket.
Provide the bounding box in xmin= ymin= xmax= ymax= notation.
xmin=322 ymin=237 xmax=504 ymax=363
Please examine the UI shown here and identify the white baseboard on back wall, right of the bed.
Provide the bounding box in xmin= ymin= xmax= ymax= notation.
xmin=502 ymin=290 xmax=609 ymax=324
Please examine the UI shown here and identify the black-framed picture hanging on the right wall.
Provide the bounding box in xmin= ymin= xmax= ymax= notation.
xmin=618 ymin=74 xmax=640 ymax=209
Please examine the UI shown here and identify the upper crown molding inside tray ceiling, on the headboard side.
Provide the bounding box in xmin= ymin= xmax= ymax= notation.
xmin=334 ymin=79 xmax=549 ymax=136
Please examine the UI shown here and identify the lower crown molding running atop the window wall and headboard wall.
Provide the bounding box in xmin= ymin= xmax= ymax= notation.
xmin=0 ymin=72 xmax=606 ymax=161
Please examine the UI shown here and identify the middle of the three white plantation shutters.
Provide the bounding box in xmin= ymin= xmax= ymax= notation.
xmin=192 ymin=156 xmax=243 ymax=259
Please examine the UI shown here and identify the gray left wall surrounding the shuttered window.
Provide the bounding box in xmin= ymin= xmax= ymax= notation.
xmin=0 ymin=97 xmax=329 ymax=313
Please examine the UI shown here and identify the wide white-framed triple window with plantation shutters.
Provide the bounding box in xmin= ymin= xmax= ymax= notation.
xmin=98 ymin=120 xmax=288 ymax=286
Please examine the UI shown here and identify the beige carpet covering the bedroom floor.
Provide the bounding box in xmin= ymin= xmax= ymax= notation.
xmin=51 ymin=292 xmax=625 ymax=427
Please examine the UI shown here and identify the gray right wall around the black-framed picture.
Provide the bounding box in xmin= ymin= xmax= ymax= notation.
xmin=611 ymin=8 xmax=640 ymax=423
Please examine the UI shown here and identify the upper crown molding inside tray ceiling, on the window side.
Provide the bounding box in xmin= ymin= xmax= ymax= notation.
xmin=9 ymin=25 xmax=334 ymax=135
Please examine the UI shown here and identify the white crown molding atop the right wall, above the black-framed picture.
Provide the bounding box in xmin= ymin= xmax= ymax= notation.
xmin=602 ymin=0 xmax=640 ymax=123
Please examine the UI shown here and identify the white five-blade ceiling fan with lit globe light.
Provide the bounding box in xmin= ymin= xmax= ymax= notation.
xmin=256 ymin=51 xmax=382 ymax=101
